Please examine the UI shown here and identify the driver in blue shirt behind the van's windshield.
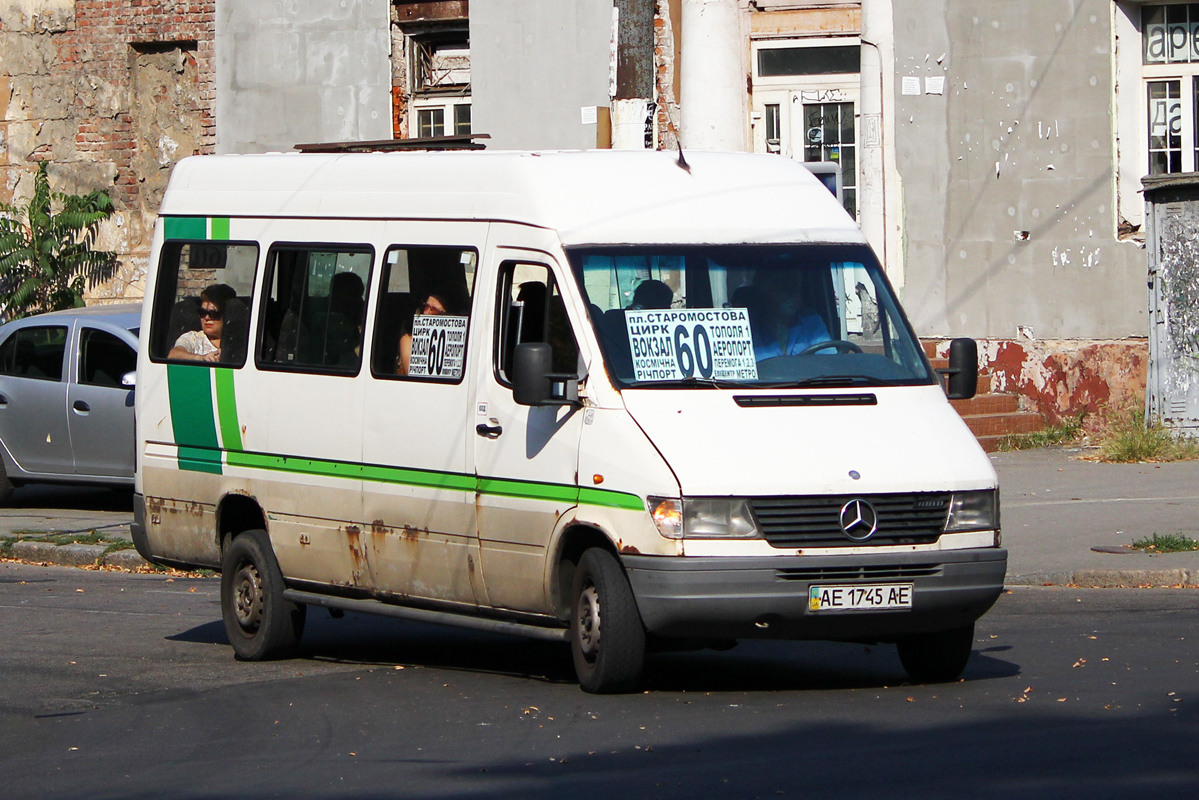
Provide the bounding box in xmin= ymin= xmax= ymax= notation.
xmin=746 ymin=269 xmax=832 ymax=361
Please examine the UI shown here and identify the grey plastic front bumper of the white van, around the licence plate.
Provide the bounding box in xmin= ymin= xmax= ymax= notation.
xmin=621 ymin=547 xmax=1007 ymax=642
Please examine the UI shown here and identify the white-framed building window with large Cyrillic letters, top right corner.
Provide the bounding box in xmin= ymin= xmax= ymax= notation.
xmin=1140 ymin=2 xmax=1199 ymax=175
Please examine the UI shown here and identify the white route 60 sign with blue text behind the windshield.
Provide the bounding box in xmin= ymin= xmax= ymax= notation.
xmin=625 ymin=308 xmax=758 ymax=380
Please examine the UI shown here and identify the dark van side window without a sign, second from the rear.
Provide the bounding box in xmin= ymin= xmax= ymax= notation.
xmin=258 ymin=245 xmax=374 ymax=374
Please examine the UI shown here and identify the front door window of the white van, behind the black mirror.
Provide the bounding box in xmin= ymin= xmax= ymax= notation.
xmin=495 ymin=261 xmax=579 ymax=384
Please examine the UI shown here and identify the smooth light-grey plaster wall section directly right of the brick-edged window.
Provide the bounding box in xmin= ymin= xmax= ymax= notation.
xmin=470 ymin=0 xmax=611 ymax=150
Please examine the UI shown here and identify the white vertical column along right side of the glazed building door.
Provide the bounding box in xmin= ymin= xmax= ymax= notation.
xmin=857 ymin=0 xmax=904 ymax=290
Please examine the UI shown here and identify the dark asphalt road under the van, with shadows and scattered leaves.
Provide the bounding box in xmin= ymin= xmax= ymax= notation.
xmin=0 ymin=564 xmax=1199 ymax=799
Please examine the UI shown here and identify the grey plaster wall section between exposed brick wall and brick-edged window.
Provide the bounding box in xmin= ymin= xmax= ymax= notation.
xmin=216 ymin=0 xmax=392 ymax=154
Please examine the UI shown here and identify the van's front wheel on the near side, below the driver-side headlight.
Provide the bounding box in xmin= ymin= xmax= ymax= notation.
xmin=571 ymin=548 xmax=645 ymax=694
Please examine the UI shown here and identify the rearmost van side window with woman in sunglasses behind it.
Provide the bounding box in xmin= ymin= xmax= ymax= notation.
xmin=150 ymin=241 xmax=258 ymax=367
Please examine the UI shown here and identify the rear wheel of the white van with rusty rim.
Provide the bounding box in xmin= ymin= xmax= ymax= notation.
xmin=221 ymin=530 xmax=307 ymax=661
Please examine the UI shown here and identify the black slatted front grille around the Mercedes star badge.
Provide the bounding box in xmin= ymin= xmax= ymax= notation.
xmin=749 ymin=492 xmax=951 ymax=547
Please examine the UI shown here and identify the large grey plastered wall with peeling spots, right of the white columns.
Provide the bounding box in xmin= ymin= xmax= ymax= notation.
xmin=892 ymin=0 xmax=1147 ymax=347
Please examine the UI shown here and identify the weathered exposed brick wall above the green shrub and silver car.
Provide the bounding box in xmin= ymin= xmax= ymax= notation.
xmin=0 ymin=0 xmax=216 ymax=300
